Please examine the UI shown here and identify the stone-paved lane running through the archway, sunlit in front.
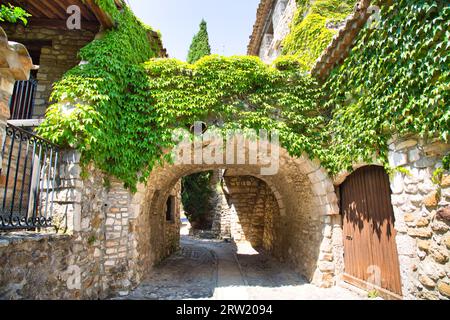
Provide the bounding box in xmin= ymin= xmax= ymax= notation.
xmin=116 ymin=236 xmax=364 ymax=300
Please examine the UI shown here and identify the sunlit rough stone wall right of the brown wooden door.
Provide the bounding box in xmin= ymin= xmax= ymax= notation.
xmin=390 ymin=137 xmax=450 ymax=299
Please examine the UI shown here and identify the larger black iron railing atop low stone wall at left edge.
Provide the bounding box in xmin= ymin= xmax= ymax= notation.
xmin=0 ymin=124 xmax=60 ymax=230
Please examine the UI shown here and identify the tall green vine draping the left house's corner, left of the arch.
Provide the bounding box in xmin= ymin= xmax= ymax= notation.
xmin=38 ymin=0 xmax=161 ymax=187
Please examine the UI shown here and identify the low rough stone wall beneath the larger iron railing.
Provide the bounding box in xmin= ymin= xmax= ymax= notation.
xmin=0 ymin=232 xmax=74 ymax=300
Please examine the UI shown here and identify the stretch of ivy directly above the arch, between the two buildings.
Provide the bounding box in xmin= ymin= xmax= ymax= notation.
xmin=146 ymin=55 xmax=324 ymax=162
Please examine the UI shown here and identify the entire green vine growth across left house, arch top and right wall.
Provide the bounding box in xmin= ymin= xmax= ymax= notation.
xmin=39 ymin=0 xmax=450 ymax=189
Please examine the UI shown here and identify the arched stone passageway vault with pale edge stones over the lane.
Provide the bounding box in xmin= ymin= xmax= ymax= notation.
xmin=115 ymin=140 xmax=342 ymax=287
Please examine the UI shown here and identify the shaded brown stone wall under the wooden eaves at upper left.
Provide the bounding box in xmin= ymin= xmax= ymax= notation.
xmin=2 ymin=24 xmax=95 ymax=119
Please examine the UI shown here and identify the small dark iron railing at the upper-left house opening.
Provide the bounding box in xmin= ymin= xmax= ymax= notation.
xmin=9 ymin=79 xmax=37 ymax=120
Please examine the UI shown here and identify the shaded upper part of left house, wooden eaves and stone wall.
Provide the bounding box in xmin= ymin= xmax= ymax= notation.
xmin=0 ymin=0 xmax=166 ymax=123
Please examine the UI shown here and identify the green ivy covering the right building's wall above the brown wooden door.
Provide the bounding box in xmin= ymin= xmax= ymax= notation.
xmin=324 ymin=0 xmax=450 ymax=172
